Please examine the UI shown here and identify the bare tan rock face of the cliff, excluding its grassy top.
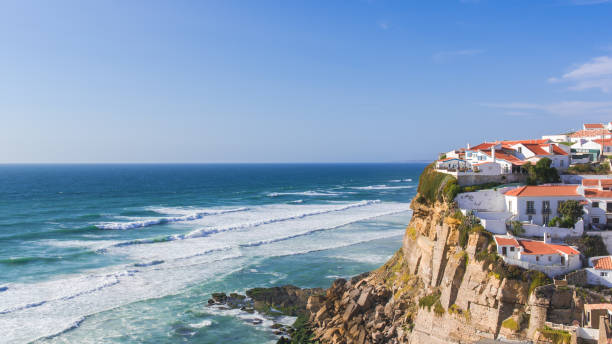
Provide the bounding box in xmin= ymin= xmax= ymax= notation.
xmin=308 ymin=201 xmax=546 ymax=344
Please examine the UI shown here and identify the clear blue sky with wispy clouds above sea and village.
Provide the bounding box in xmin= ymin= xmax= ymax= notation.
xmin=0 ymin=0 xmax=612 ymax=163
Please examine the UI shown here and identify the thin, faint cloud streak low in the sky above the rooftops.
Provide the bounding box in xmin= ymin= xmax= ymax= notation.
xmin=480 ymin=101 xmax=612 ymax=117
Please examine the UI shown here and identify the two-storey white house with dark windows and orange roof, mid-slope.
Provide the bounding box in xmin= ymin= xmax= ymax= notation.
xmin=505 ymin=185 xmax=584 ymax=226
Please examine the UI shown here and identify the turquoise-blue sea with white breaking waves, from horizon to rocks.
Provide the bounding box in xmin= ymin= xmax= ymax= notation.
xmin=0 ymin=164 xmax=425 ymax=343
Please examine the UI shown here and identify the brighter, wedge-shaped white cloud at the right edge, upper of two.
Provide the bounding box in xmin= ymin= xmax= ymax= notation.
xmin=548 ymin=56 xmax=612 ymax=93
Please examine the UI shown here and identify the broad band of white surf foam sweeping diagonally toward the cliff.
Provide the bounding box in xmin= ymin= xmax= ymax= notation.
xmin=0 ymin=201 xmax=409 ymax=343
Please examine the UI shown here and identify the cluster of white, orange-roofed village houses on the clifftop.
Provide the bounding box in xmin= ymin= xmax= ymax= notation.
xmin=435 ymin=122 xmax=612 ymax=343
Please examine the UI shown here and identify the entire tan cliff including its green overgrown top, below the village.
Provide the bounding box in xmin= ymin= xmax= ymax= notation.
xmin=307 ymin=165 xmax=601 ymax=344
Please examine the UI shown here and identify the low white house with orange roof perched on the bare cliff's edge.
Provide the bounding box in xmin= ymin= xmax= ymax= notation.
xmin=495 ymin=235 xmax=582 ymax=277
